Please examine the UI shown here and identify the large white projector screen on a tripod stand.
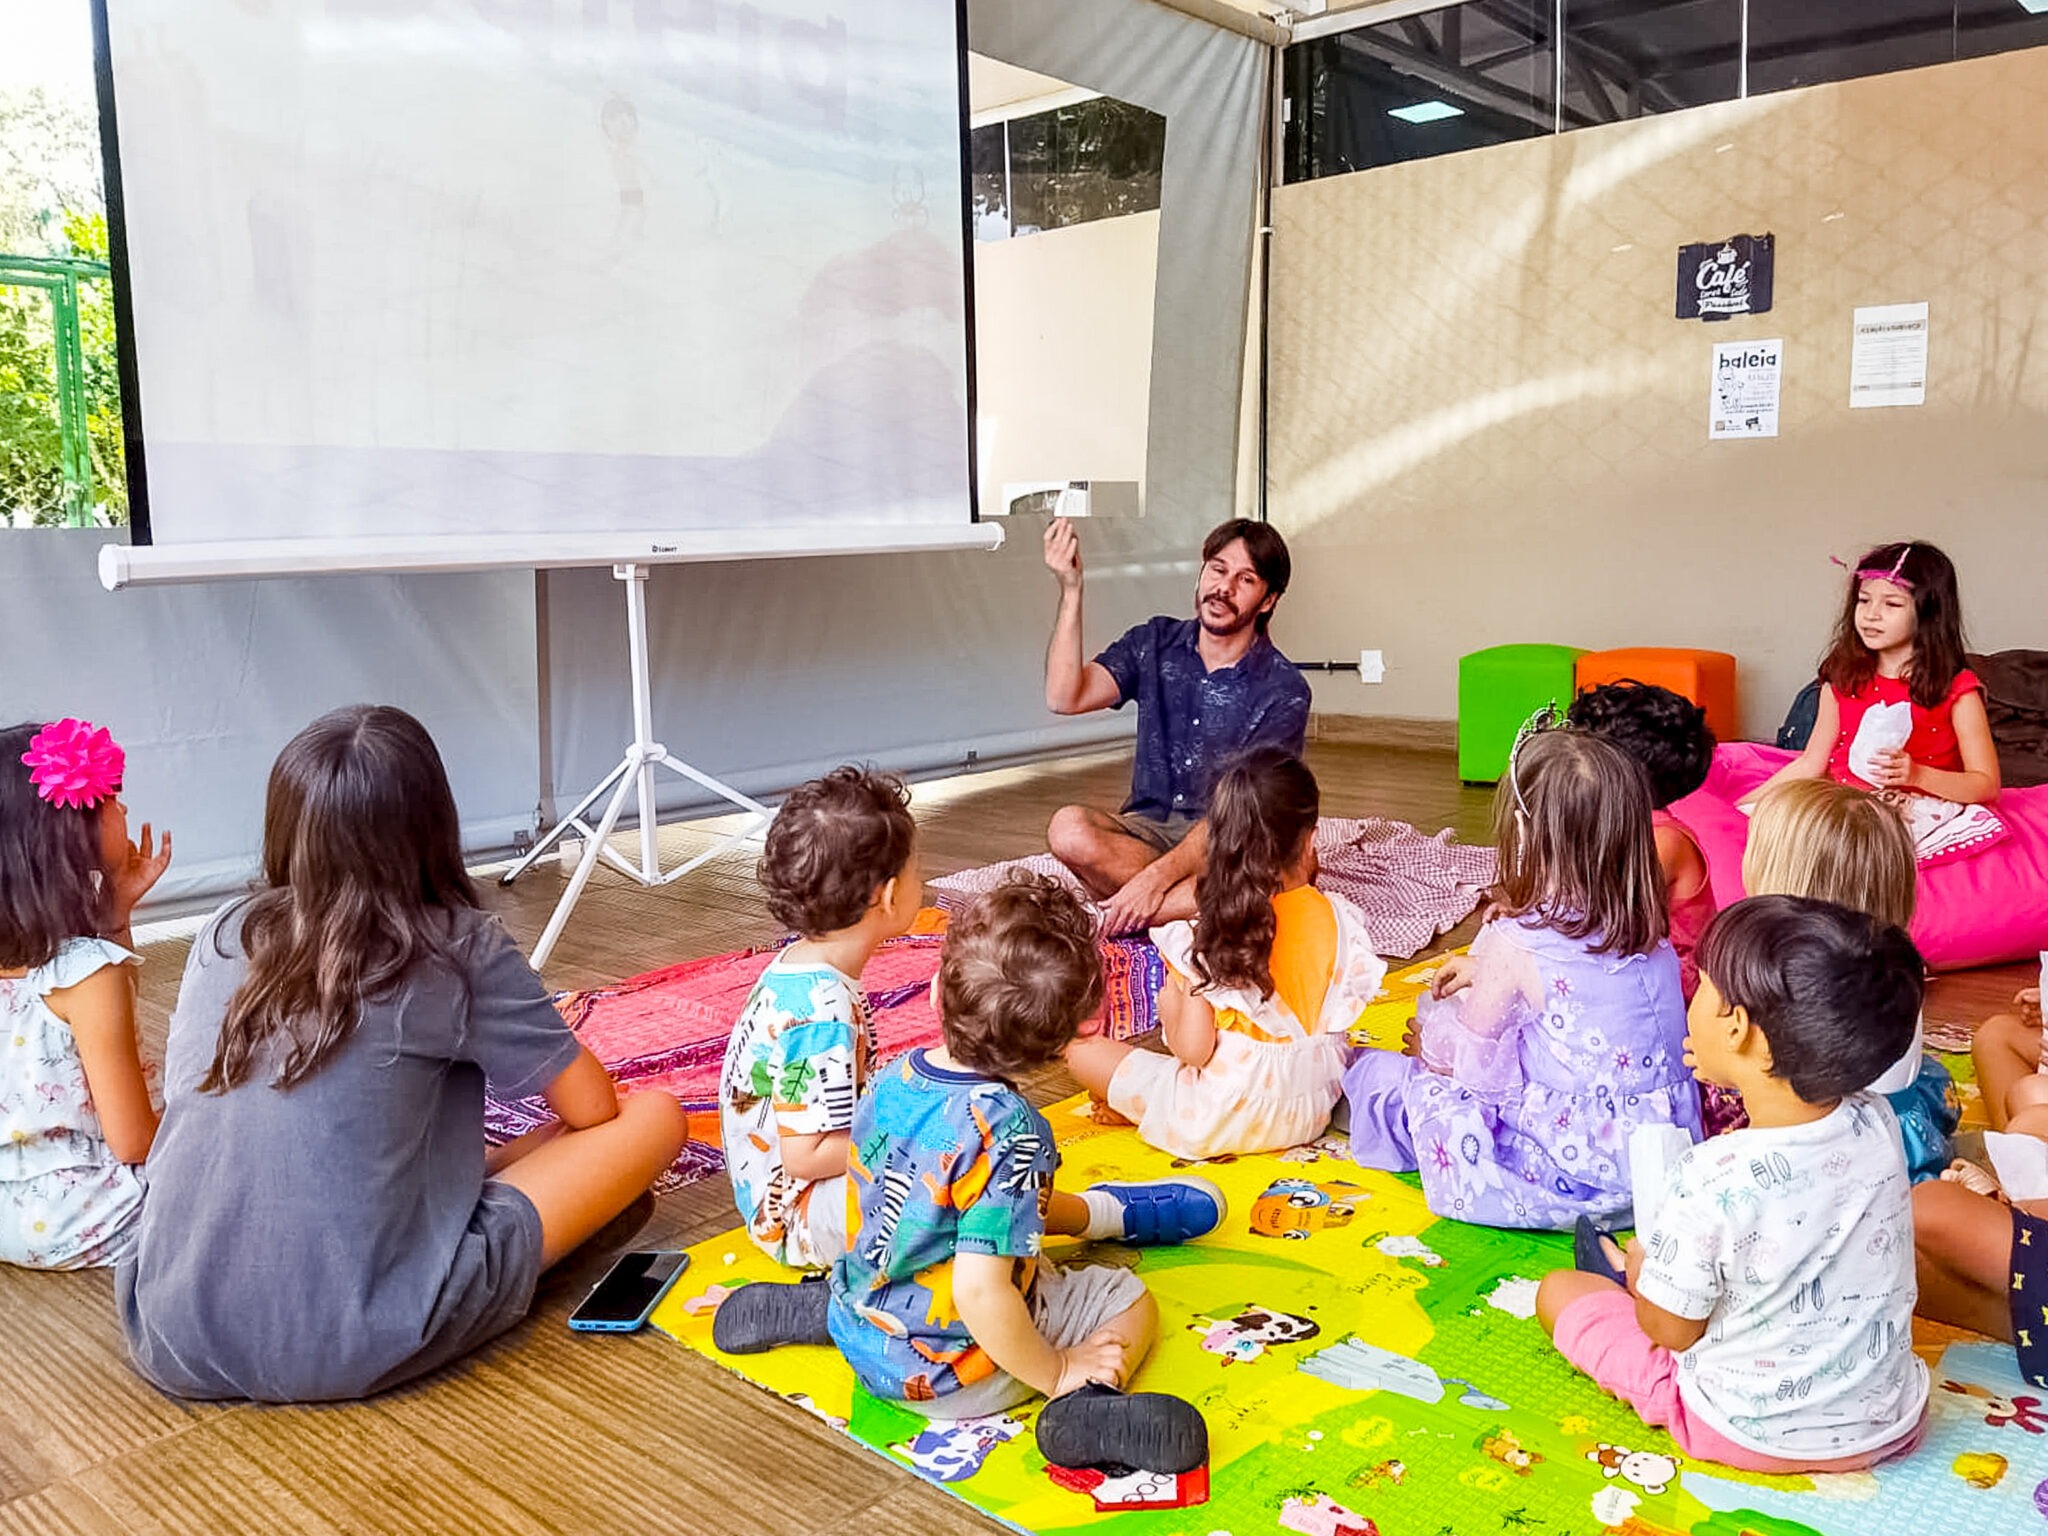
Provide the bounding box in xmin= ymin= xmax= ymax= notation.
xmin=100 ymin=0 xmax=993 ymax=573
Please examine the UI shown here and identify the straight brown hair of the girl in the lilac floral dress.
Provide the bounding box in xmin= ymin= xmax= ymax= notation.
xmin=1489 ymin=727 xmax=1669 ymax=954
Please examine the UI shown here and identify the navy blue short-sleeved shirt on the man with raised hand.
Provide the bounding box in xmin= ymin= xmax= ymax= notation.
xmin=1096 ymin=616 xmax=1309 ymax=821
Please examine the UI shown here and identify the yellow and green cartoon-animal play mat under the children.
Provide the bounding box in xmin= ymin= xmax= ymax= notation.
xmin=653 ymin=1098 xmax=2048 ymax=1536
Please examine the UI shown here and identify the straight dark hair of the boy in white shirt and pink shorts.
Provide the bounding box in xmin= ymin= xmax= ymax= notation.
xmin=1700 ymin=897 xmax=1925 ymax=1104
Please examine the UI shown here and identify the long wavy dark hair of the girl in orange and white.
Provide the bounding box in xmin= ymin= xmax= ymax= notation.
xmin=1194 ymin=748 xmax=1323 ymax=997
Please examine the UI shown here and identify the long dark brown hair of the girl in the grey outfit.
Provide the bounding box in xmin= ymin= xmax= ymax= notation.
xmin=199 ymin=705 xmax=479 ymax=1094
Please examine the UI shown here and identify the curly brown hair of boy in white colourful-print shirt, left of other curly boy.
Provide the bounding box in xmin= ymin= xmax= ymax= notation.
xmin=754 ymin=764 xmax=918 ymax=938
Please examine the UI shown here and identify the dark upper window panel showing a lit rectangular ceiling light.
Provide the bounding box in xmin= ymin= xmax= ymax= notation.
xmin=1284 ymin=0 xmax=1556 ymax=182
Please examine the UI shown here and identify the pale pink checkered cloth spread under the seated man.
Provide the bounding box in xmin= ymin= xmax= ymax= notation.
xmin=928 ymin=817 xmax=1495 ymax=961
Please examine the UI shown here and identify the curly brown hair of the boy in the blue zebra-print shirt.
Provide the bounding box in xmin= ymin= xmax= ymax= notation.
xmin=938 ymin=874 xmax=1102 ymax=1081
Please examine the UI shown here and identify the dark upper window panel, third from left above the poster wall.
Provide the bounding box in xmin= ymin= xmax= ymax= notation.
xmin=1749 ymin=0 xmax=1957 ymax=96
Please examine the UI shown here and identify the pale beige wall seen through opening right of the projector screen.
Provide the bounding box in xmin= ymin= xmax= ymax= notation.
xmin=975 ymin=213 xmax=1159 ymax=516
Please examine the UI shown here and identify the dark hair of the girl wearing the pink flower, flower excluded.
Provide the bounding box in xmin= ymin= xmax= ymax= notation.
xmin=0 ymin=721 xmax=111 ymax=971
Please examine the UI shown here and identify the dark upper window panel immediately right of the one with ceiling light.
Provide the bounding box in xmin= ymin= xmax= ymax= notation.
xmin=1563 ymin=0 xmax=1743 ymax=129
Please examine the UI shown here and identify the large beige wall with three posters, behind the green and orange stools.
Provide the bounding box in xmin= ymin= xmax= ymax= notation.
xmin=1270 ymin=49 xmax=2048 ymax=735
